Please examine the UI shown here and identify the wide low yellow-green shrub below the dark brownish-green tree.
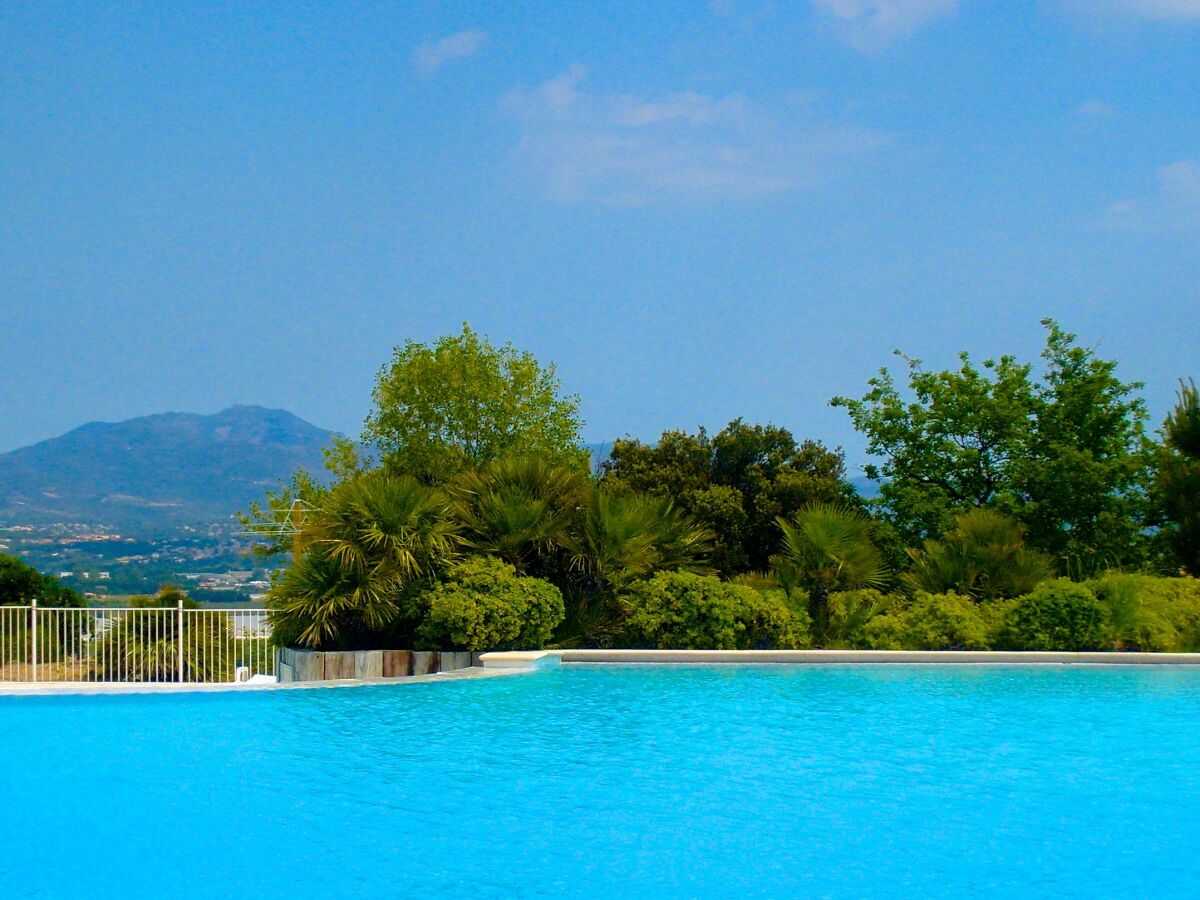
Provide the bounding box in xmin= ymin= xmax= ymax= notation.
xmin=622 ymin=571 xmax=808 ymax=650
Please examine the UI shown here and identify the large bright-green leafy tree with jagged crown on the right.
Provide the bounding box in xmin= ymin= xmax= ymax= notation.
xmin=833 ymin=319 xmax=1150 ymax=575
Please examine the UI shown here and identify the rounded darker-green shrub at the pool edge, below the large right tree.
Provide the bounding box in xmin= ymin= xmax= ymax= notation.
xmin=1002 ymin=578 xmax=1111 ymax=650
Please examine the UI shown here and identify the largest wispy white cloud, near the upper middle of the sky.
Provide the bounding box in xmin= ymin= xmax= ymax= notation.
xmin=500 ymin=65 xmax=882 ymax=204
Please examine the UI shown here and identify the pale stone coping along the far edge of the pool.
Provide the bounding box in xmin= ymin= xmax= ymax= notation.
xmin=0 ymin=650 xmax=1200 ymax=696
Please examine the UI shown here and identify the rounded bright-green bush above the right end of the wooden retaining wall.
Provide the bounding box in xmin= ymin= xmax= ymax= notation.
xmin=416 ymin=557 xmax=564 ymax=650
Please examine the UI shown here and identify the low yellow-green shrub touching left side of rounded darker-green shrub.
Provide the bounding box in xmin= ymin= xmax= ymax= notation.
xmin=863 ymin=592 xmax=990 ymax=650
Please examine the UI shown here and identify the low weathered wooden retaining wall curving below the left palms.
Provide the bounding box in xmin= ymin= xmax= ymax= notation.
xmin=275 ymin=647 xmax=479 ymax=682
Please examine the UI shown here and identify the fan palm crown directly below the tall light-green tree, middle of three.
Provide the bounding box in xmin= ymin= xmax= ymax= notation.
xmin=449 ymin=456 xmax=589 ymax=575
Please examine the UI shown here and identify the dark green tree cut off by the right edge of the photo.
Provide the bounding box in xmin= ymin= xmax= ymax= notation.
xmin=1154 ymin=382 xmax=1200 ymax=576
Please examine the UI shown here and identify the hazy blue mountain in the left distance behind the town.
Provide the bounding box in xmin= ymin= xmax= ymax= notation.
xmin=0 ymin=406 xmax=334 ymax=532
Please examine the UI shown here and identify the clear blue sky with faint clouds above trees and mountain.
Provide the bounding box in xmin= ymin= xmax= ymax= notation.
xmin=0 ymin=0 xmax=1200 ymax=472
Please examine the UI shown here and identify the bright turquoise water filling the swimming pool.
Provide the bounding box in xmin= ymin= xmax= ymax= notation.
xmin=0 ymin=666 xmax=1200 ymax=898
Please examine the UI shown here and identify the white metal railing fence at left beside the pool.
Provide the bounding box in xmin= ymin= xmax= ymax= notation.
xmin=0 ymin=604 xmax=275 ymax=684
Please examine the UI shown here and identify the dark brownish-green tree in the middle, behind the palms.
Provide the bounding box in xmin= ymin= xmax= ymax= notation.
xmin=602 ymin=419 xmax=858 ymax=577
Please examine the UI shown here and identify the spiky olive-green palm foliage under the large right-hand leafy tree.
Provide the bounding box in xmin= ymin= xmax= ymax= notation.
xmin=901 ymin=509 xmax=1052 ymax=600
